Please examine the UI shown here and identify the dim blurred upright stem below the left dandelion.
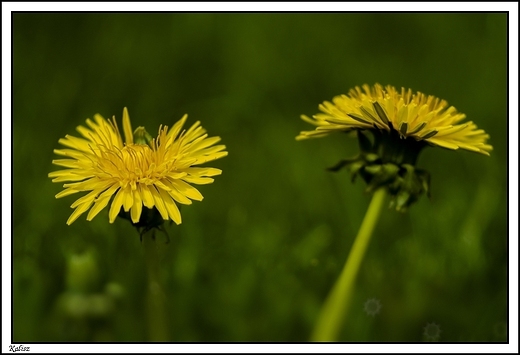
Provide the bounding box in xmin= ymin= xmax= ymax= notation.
xmin=143 ymin=228 xmax=169 ymax=342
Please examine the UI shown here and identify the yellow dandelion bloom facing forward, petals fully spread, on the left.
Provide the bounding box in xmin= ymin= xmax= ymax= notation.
xmin=49 ymin=107 xmax=228 ymax=225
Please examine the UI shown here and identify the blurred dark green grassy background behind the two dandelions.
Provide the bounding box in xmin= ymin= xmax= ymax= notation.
xmin=13 ymin=13 xmax=507 ymax=342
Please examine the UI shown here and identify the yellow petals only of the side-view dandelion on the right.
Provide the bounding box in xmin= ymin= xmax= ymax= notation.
xmin=296 ymin=84 xmax=493 ymax=155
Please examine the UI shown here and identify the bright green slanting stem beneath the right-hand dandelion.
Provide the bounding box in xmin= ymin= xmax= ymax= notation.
xmin=311 ymin=188 xmax=386 ymax=341
